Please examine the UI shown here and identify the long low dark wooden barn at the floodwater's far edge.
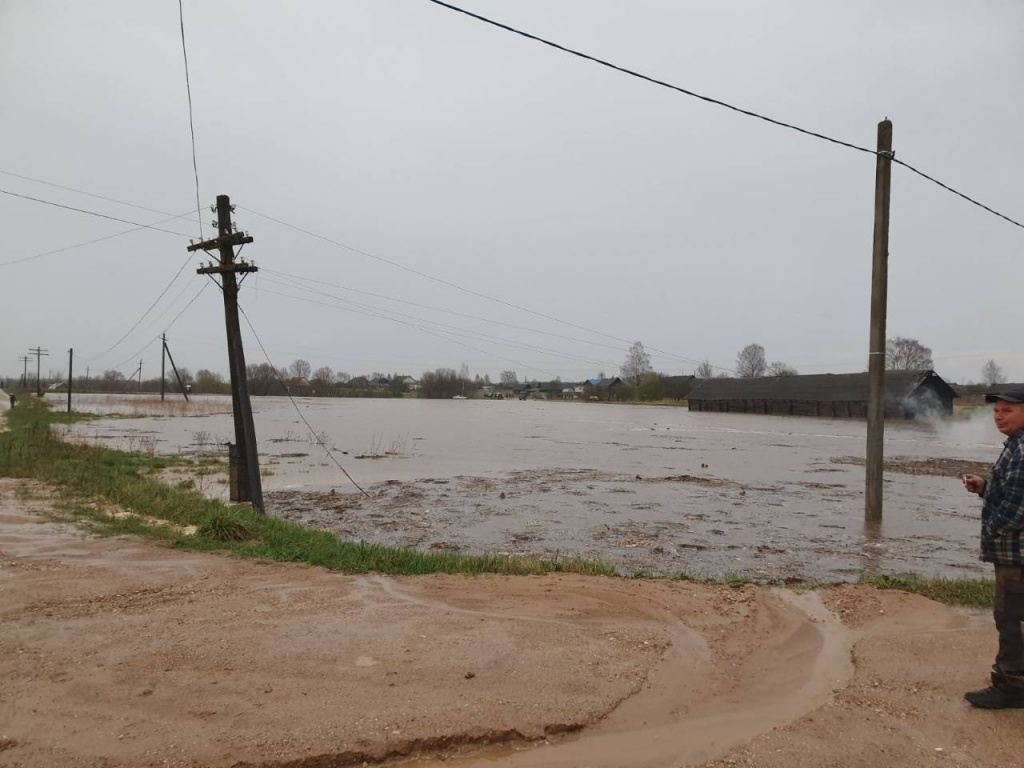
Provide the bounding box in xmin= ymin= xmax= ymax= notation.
xmin=689 ymin=371 xmax=956 ymax=419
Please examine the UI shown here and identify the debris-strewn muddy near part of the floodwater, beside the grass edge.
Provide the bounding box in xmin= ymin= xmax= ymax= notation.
xmin=266 ymin=457 xmax=989 ymax=581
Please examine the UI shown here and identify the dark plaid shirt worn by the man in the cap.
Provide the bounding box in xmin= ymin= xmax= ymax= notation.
xmin=981 ymin=431 xmax=1024 ymax=567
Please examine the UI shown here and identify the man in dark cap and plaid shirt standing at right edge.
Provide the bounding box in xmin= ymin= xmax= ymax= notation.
xmin=964 ymin=389 xmax=1024 ymax=710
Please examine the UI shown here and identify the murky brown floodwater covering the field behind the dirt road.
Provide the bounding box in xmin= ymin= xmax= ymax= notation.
xmin=66 ymin=395 xmax=1001 ymax=580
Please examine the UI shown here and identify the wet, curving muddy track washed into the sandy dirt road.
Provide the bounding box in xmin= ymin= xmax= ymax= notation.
xmin=344 ymin=577 xmax=853 ymax=768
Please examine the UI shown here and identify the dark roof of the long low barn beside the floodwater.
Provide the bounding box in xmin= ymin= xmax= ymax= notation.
xmin=689 ymin=371 xmax=956 ymax=400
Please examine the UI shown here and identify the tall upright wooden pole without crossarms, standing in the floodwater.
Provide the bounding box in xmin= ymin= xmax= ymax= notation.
xmin=864 ymin=119 xmax=893 ymax=523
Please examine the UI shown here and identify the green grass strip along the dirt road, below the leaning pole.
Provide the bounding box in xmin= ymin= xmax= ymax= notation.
xmin=0 ymin=397 xmax=615 ymax=575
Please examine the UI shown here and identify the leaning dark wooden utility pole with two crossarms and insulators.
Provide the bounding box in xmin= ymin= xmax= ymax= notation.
xmin=188 ymin=195 xmax=263 ymax=512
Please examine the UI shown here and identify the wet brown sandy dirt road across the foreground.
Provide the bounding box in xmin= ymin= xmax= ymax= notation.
xmin=0 ymin=480 xmax=1024 ymax=768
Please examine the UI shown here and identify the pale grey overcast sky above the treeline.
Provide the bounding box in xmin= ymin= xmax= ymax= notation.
xmin=0 ymin=0 xmax=1024 ymax=381
